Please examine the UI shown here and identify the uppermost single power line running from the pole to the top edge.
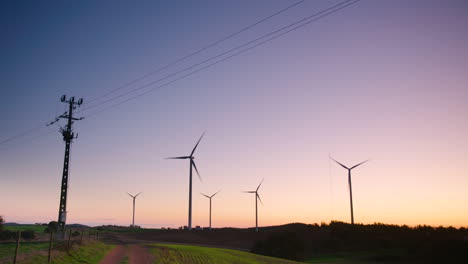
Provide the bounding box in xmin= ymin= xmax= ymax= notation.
xmin=82 ymin=0 xmax=305 ymax=104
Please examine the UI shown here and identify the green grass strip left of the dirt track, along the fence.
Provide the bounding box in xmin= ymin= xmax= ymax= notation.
xmin=16 ymin=242 xmax=115 ymax=264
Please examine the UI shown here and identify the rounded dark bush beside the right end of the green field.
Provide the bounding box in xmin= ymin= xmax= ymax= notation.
xmin=251 ymin=232 xmax=307 ymax=261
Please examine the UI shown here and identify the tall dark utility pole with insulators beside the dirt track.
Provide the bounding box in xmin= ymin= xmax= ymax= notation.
xmin=48 ymin=95 xmax=83 ymax=234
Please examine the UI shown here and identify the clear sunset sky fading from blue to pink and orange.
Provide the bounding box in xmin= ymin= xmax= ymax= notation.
xmin=0 ymin=0 xmax=468 ymax=227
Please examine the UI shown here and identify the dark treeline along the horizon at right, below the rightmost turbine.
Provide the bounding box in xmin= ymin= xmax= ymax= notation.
xmin=251 ymin=222 xmax=468 ymax=263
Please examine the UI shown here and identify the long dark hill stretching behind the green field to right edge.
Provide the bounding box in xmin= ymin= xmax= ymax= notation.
xmin=104 ymin=222 xmax=468 ymax=263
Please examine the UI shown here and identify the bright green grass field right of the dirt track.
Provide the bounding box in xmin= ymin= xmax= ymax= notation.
xmin=151 ymin=244 xmax=300 ymax=264
